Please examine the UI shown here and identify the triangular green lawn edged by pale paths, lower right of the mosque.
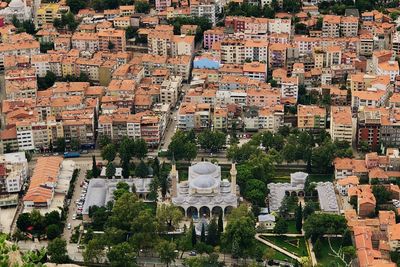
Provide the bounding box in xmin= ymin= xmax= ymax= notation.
xmin=262 ymin=236 xmax=308 ymax=257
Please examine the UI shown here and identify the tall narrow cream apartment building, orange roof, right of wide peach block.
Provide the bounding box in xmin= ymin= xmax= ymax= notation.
xmin=330 ymin=106 xmax=353 ymax=144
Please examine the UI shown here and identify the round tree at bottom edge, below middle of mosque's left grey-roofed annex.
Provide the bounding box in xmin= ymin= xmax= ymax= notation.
xmin=107 ymin=242 xmax=137 ymax=267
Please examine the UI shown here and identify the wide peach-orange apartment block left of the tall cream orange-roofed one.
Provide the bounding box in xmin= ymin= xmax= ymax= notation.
xmin=297 ymin=105 xmax=326 ymax=130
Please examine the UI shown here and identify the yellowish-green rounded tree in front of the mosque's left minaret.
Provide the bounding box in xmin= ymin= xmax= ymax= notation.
xmin=156 ymin=204 xmax=183 ymax=231
